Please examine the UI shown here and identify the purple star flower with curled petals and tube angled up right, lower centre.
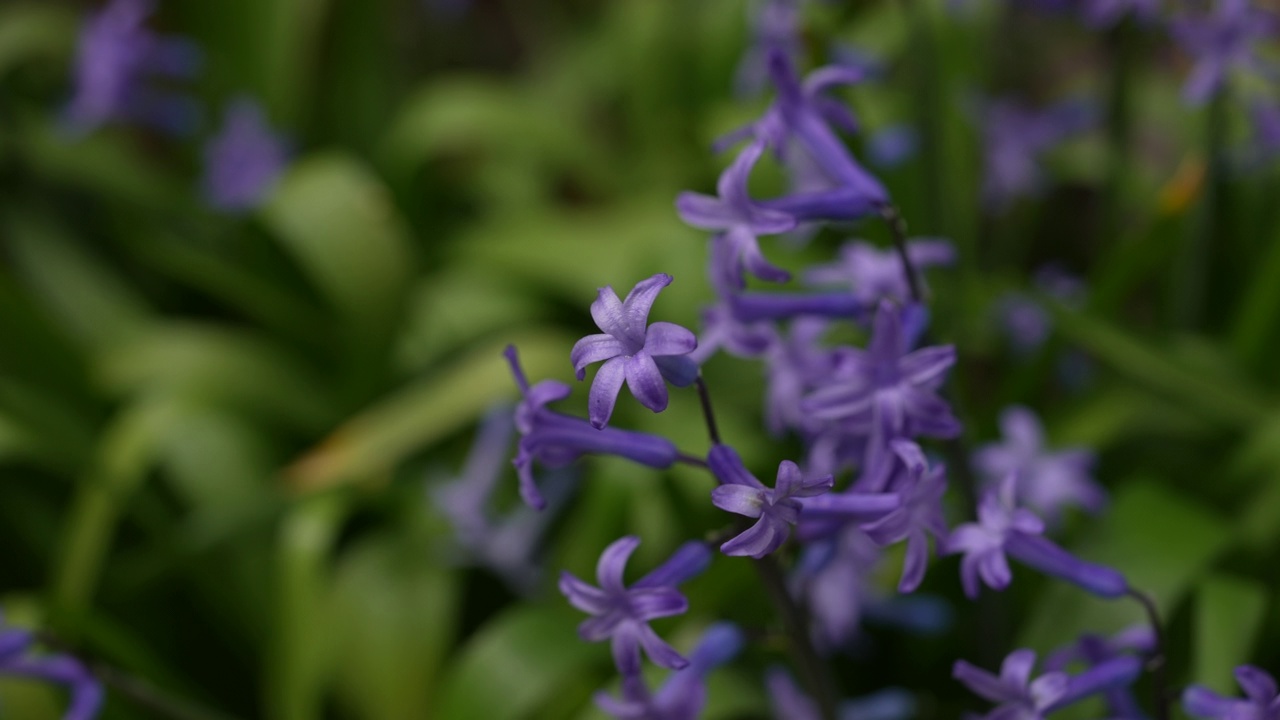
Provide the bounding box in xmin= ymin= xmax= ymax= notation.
xmin=559 ymin=536 xmax=712 ymax=678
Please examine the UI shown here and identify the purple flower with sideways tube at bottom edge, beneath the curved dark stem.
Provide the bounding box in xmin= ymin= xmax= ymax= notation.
xmin=952 ymin=650 xmax=1142 ymax=720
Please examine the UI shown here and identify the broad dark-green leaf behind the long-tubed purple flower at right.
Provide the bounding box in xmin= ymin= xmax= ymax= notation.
xmin=1014 ymin=478 xmax=1231 ymax=651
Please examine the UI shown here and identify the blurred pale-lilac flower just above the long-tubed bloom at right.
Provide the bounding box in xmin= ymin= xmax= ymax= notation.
xmin=973 ymin=406 xmax=1107 ymax=524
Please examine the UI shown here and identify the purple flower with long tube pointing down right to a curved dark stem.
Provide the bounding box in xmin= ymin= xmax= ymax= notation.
xmin=946 ymin=475 xmax=1129 ymax=598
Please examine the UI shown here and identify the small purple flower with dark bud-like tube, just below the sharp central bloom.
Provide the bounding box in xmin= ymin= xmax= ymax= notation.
xmin=707 ymin=445 xmax=832 ymax=559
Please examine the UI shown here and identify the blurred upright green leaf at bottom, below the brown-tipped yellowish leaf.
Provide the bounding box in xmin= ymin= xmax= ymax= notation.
xmin=332 ymin=527 xmax=461 ymax=720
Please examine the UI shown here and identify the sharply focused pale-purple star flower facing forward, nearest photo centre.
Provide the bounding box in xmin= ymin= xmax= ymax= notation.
xmin=570 ymin=273 xmax=698 ymax=428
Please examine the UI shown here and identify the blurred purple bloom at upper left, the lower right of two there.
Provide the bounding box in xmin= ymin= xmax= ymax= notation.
xmin=204 ymin=97 xmax=288 ymax=211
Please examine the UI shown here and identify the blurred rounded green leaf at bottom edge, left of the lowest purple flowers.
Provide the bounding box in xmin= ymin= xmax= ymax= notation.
xmin=431 ymin=603 xmax=603 ymax=720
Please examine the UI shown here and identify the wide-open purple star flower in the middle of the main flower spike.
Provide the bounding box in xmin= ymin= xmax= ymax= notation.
xmin=803 ymin=302 xmax=960 ymax=448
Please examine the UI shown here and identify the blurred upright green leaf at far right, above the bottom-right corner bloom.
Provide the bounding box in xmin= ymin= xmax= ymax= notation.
xmin=1192 ymin=575 xmax=1268 ymax=696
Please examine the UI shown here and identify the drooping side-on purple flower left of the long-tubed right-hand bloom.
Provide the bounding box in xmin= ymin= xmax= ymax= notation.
xmin=865 ymin=439 xmax=947 ymax=593
